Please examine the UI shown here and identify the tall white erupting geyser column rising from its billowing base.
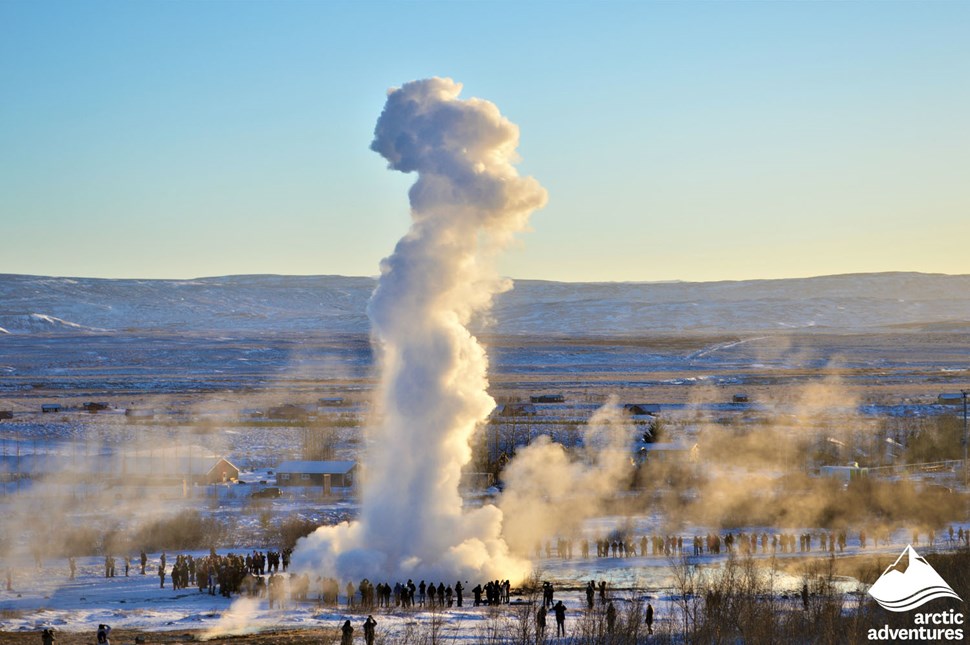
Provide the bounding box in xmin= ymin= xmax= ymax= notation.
xmin=293 ymin=78 xmax=546 ymax=580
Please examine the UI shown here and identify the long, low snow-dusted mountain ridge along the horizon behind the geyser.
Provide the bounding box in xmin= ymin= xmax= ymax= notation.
xmin=0 ymin=273 xmax=970 ymax=336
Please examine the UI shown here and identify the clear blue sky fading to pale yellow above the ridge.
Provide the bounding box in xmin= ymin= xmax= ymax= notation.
xmin=0 ymin=0 xmax=970 ymax=281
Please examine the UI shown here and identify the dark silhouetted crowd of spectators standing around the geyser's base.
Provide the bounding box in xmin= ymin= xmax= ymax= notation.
xmin=28 ymin=527 xmax=970 ymax=645
